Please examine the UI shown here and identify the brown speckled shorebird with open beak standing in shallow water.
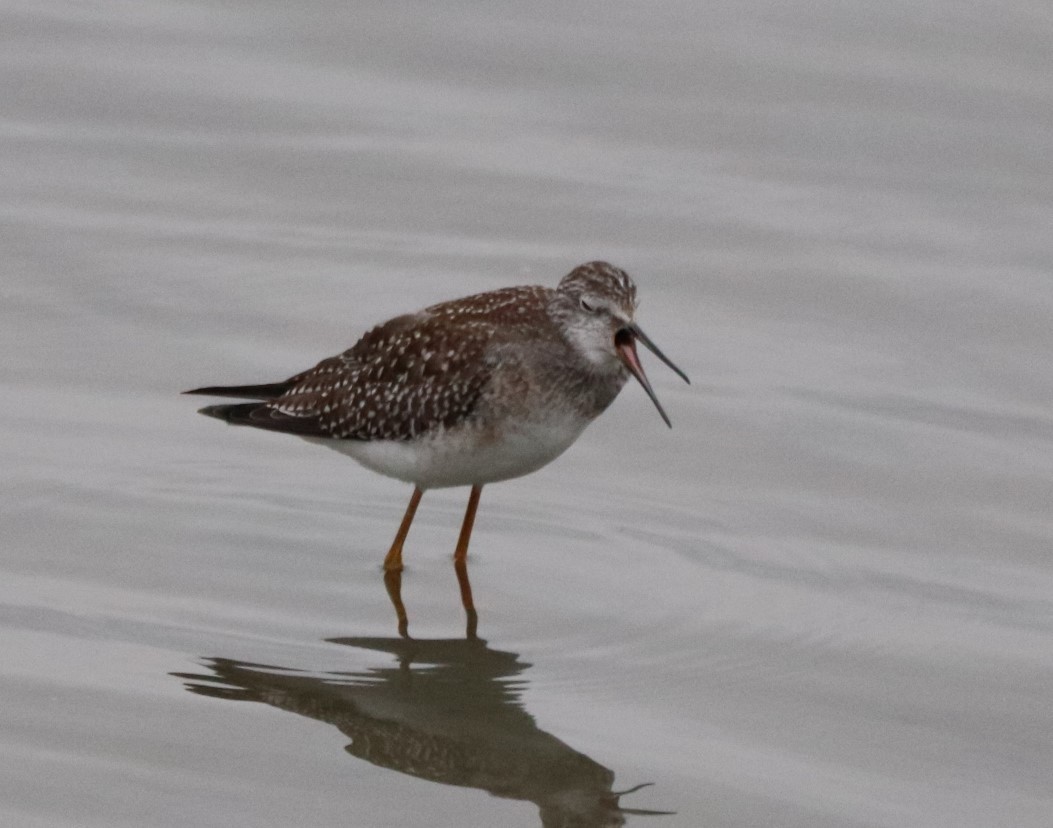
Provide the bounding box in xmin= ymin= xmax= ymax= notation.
xmin=184 ymin=261 xmax=691 ymax=573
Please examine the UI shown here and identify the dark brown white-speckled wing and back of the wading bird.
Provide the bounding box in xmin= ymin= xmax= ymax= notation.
xmin=229 ymin=288 xmax=547 ymax=440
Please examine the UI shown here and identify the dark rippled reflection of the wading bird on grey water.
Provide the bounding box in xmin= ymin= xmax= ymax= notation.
xmin=173 ymin=573 xmax=670 ymax=828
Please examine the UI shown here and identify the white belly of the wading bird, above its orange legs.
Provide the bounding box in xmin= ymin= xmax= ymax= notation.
xmin=306 ymin=417 xmax=589 ymax=489
